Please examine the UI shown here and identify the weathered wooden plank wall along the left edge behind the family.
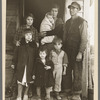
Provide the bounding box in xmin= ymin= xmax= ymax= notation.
xmin=5 ymin=0 xmax=19 ymax=90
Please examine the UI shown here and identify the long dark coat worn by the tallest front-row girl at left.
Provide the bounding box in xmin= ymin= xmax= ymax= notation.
xmin=13 ymin=39 xmax=37 ymax=83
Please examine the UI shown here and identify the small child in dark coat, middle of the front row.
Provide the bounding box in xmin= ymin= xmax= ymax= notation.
xmin=35 ymin=47 xmax=54 ymax=100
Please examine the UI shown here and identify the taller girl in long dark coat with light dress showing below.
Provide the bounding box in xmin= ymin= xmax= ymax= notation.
xmin=12 ymin=29 xmax=37 ymax=100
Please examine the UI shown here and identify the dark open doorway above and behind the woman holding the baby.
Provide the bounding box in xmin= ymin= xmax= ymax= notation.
xmin=24 ymin=0 xmax=65 ymax=30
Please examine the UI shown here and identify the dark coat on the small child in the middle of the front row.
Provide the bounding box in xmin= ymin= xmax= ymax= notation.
xmin=35 ymin=59 xmax=54 ymax=87
